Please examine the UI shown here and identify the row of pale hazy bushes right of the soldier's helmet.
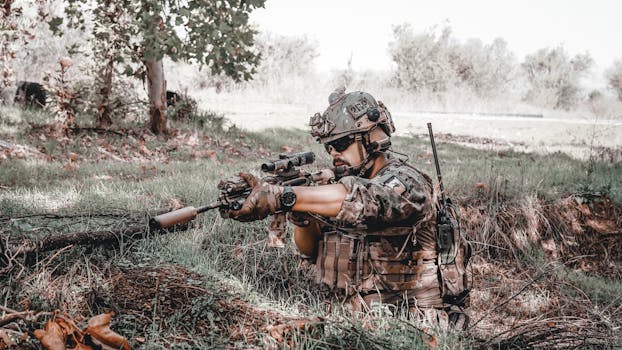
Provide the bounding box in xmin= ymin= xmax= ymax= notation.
xmin=389 ymin=25 xmax=622 ymax=110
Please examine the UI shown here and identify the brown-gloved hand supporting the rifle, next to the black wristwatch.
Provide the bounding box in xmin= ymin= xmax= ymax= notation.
xmin=220 ymin=173 xmax=283 ymax=222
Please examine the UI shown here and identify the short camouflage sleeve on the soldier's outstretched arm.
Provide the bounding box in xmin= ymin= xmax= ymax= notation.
xmin=336 ymin=168 xmax=432 ymax=225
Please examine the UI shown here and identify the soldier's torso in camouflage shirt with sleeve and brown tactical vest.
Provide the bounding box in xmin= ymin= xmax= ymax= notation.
xmin=316 ymin=156 xmax=442 ymax=306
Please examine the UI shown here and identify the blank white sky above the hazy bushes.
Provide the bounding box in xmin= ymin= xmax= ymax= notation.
xmin=251 ymin=0 xmax=622 ymax=75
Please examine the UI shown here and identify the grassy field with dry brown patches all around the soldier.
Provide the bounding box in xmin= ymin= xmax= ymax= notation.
xmin=0 ymin=95 xmax=622 ymax=349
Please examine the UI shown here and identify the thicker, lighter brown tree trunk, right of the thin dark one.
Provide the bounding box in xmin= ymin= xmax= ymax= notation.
xmin=145 ymin=59 xmax=167 ymax=135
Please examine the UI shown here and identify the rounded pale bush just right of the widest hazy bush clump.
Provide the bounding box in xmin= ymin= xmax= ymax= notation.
xmin=521 ymin=46 xmax=594 ymax=110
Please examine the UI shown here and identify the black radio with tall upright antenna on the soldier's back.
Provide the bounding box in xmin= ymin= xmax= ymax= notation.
xmin=428 ymin=123 xmax=458 ymax=264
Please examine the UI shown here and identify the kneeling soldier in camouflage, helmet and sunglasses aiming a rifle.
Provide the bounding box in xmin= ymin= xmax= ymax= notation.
xmin=227 ymin=89 xmax=468 ymax=328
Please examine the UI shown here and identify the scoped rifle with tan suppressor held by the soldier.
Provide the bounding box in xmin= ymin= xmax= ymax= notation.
xmin=149 ymin=152 xmax=339 ymax=246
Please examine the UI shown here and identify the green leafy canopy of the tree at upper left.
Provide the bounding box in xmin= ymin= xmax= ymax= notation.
xmin=56 ymin=0 xmax=264 ymax=80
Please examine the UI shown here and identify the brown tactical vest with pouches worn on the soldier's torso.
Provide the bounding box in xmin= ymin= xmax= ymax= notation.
xmin=316 ymin=160 xmax=443 ymax=308
